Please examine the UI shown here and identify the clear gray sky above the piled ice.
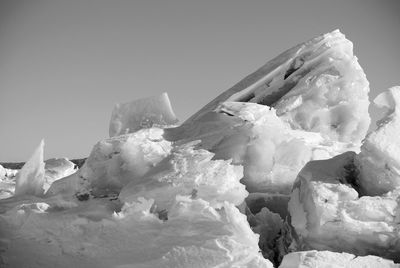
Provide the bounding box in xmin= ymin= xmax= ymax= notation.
xmin=0 ymin=0 xmax=400 ymax=161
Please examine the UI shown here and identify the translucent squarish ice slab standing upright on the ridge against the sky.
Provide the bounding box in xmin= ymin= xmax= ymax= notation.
xmin=109 ymin=93 xmax=178 ymax=137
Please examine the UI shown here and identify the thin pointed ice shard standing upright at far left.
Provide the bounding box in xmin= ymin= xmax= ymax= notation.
xmin=15 ymin=140 xmax=45 ymax=196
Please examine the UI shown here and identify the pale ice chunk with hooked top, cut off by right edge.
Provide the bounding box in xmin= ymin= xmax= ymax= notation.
xmin=357 ymin=87 xmax=400 ymax=195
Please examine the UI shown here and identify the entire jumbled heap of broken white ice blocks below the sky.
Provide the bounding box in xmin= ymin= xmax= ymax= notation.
xmin=0 ymin=31 xmax=400 ymax=268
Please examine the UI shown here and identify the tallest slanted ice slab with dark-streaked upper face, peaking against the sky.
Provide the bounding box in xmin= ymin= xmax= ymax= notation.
xmin=183 ymin=30 xmax=370 ymax=144
